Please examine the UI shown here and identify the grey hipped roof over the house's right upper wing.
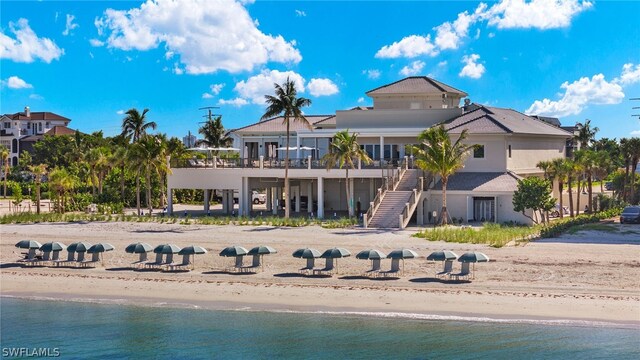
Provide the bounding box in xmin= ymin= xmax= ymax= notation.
xmin=444 ymin=105 xmax=573 ymax=137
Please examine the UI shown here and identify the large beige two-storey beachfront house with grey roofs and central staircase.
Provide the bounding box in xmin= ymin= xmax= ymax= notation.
xmin=168 ymin=76 xmax=572 ymax=227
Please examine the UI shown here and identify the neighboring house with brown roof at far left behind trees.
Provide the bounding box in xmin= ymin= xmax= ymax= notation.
xmin=0 ymin=106 xmax=75 ymax=166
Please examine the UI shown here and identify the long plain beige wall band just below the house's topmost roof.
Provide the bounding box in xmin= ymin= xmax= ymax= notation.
xmin=336 ymin=107 xmax=462 ymax=130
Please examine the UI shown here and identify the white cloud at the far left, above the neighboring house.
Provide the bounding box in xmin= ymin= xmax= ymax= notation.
xmin=0 ymin=18 xmax=64 ymax=63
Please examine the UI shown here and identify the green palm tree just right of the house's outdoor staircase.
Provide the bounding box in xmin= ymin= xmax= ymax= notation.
xmin=413 ymin=125 xmax=476 ymax=225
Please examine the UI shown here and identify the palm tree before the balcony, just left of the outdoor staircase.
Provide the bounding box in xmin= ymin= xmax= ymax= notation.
xmin=322 ymin=129 xmax=371 ymax=217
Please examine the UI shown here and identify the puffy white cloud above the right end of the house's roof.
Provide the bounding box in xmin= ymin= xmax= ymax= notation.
xmin=525 ymin=74 xmax=624 ymax=117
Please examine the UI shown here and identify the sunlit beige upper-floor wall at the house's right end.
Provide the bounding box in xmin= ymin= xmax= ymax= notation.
xmin=506 ymin=135 xmax=566 ymax=174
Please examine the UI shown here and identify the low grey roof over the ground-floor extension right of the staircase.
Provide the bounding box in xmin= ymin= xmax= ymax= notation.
xmin=433 ymin=172 xmax=521 ymax=192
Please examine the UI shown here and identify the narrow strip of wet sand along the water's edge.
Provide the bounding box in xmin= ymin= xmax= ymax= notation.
xmin=0 ymin=292 xmax=640 ymax=330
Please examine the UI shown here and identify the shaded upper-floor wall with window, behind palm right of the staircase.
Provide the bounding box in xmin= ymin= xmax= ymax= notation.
xmin=460 ymin=134 xmax=507 ymax=172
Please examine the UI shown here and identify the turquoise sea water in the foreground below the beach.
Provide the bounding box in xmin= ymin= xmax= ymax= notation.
xmin=0 ymin=298 xmax=640 ymax=359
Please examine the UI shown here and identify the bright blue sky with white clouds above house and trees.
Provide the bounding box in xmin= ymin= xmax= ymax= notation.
xmin=0 ymin=0 xmax=640 ymax=138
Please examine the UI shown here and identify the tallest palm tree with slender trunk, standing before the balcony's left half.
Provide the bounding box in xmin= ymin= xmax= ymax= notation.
xmin=260 ymin=78 xmax=311 ymax=218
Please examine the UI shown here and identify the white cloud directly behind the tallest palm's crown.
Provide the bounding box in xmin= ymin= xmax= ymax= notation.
xmin=234 ymin=69 xmax=305 ymax=105
